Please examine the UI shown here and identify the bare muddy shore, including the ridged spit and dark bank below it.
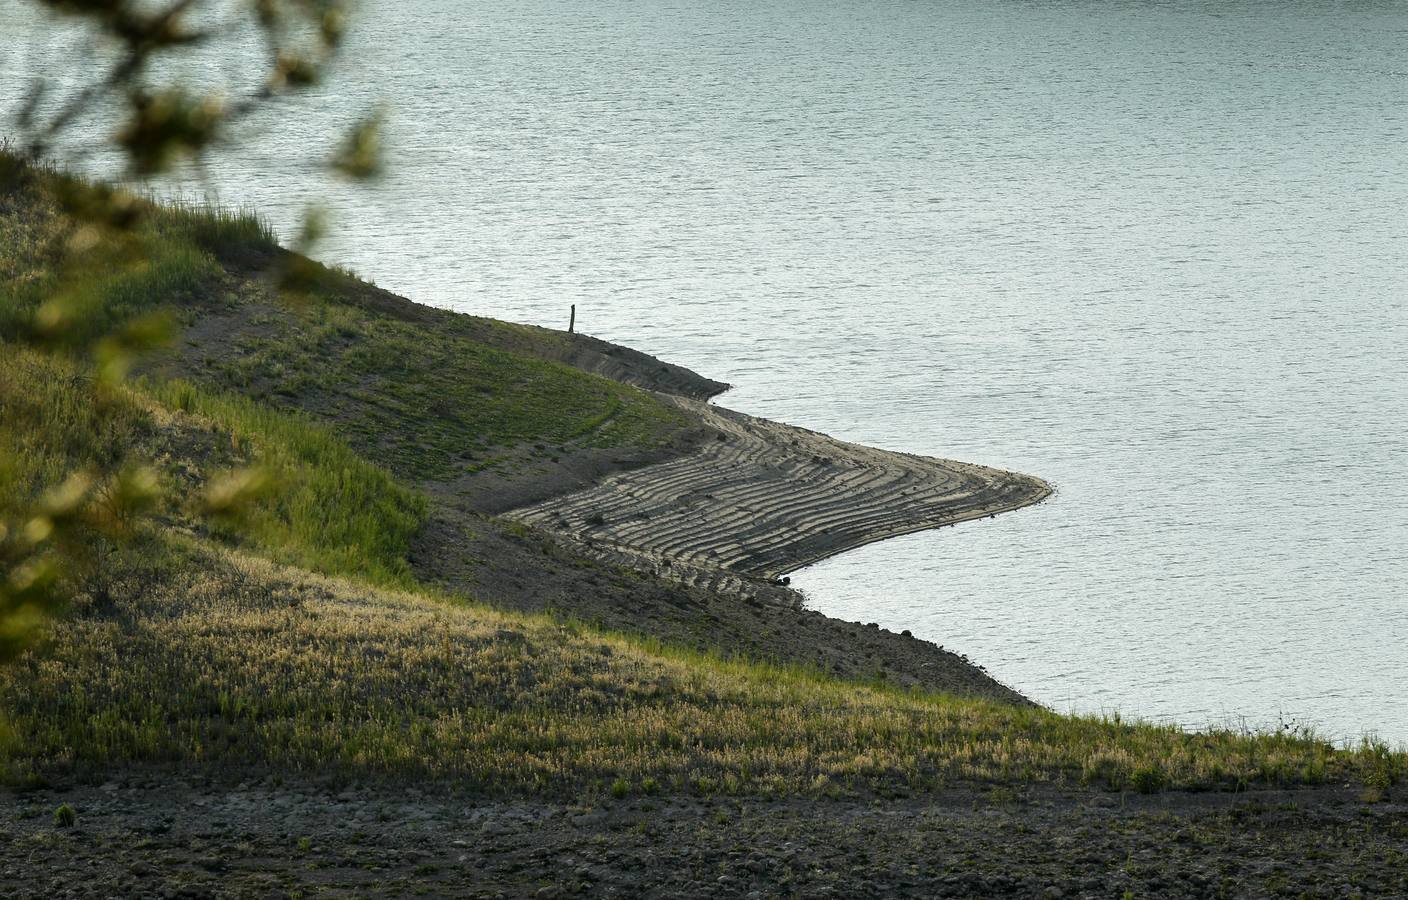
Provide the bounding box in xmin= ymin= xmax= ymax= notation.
xmin=411 ymin=343 xmax=1050 ymax=703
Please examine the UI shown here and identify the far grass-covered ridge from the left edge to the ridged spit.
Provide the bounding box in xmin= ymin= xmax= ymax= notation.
xmin=0 ymin=154 xmax=691 ymax=490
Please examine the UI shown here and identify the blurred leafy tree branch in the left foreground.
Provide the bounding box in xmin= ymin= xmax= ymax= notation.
xmin=0 ymin=0 xmax=380 ymax=662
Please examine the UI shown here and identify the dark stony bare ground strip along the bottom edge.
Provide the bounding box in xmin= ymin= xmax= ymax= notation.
xmin=0 ymin=773 xmax=1408 ymax=897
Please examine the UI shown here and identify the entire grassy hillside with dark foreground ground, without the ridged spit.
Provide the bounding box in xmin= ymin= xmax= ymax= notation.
xmin=0 ymin=158 xmax=1408 ymax=896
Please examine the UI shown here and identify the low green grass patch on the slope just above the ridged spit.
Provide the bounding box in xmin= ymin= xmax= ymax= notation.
xmin=190 ymin=284 xmax=689 ymax=480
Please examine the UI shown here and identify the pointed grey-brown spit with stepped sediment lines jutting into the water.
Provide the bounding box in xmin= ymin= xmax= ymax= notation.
xmin=508 ymin=397 xmax=1052 ymax=590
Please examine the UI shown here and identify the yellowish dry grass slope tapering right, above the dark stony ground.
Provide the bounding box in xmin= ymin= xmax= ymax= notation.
xmin=0 ymin=542 xmax=1408 ymax=794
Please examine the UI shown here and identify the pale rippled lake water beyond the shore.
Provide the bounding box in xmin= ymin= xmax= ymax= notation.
xmin=11 ymin=0 xmax=1408 ymax=741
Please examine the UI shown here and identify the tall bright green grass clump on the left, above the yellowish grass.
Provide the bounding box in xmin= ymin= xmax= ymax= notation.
xmin=0 ymin=349 xmax=425 ymax=586
